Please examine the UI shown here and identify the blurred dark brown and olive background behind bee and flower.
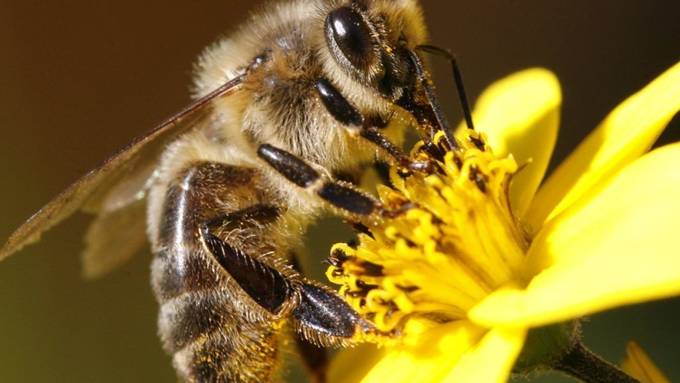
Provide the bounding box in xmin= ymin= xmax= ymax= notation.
xmin=0 ymin=0 xmax=680 ymax=382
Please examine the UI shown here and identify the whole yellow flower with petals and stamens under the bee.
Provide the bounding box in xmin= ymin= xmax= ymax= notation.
xmin=327 ymin=64 xmax=680 ymax=383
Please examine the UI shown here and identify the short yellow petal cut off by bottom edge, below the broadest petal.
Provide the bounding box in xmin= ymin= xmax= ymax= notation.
xmin=444 ymin=328 xmax=526 ymax=383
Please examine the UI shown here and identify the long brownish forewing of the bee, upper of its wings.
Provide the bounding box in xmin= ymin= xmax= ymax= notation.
xmin=0 ymin=75 xmax=244 ymax=260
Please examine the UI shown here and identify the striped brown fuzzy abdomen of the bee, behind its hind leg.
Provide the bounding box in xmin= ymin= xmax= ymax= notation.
xmin=152 ymin=163 xmax=286 ymax=382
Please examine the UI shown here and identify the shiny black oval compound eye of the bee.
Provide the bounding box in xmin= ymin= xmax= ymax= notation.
xmin=326 ymin=7 xmax=375 ymax=71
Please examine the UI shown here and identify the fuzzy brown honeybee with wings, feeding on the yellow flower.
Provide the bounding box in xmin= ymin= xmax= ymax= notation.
xmin=0 ymin=0 xmax=462 ymax=382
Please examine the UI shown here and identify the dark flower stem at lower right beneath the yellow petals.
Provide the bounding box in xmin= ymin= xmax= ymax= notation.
xmin=551 ymin=342 xmax=640 ymax=383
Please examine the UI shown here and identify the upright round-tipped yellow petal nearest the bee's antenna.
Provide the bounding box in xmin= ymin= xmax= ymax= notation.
xmin=459 ymin=68 xmax=562 ymax=216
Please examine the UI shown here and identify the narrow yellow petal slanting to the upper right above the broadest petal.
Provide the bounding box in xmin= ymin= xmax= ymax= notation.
xmin=526 ymin=63 xmax=680 ymax=229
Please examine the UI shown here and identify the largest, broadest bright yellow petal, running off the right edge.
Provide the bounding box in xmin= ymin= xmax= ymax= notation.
xmin=469 ymin=143 xmax=680 ymax=326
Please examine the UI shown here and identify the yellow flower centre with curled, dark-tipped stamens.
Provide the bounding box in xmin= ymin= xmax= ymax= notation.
xmin=326 ymin=131 xmax=528 ymax=340
